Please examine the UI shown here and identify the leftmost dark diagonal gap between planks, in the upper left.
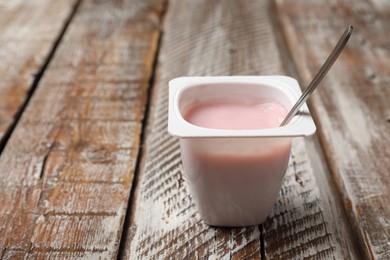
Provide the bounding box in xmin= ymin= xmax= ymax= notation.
xmin=0 ymin=0 xmax=82 ymax=156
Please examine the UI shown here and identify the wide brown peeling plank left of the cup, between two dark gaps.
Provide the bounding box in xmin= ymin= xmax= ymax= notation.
xmin=0 ymin=0 xmax=162 ymax=259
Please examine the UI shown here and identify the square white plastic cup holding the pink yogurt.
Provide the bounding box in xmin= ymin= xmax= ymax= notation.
xmin=168 ymin=76 xmax=316 ymax=226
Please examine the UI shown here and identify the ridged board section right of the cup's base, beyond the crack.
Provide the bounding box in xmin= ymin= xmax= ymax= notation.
xmin=264 ymin=139 xmax=360 ymax=259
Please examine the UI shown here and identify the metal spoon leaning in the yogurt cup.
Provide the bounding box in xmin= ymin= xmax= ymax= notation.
xmin=280 ymin=25 xmax=353 ymax=126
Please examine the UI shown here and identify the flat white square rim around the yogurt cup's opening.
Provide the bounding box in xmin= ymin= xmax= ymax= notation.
xmin=168 ymin=75 xmax=316 ymax=138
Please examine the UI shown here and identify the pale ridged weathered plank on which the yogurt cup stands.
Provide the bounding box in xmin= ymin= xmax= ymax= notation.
xmin=124 ymin=1 xmax=357 ymax=259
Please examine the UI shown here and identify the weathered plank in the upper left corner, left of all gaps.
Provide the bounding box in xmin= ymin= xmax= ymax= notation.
xmin=0 ymin=0 xmax=79 ymax=143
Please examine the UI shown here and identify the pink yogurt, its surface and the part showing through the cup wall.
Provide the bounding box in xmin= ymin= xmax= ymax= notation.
xmin=182 ymin=100 xmax=291 ymax=226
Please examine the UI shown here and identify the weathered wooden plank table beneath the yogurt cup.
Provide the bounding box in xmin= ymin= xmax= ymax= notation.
xmin=0 ymin=0 xmax=390 ymax=259
